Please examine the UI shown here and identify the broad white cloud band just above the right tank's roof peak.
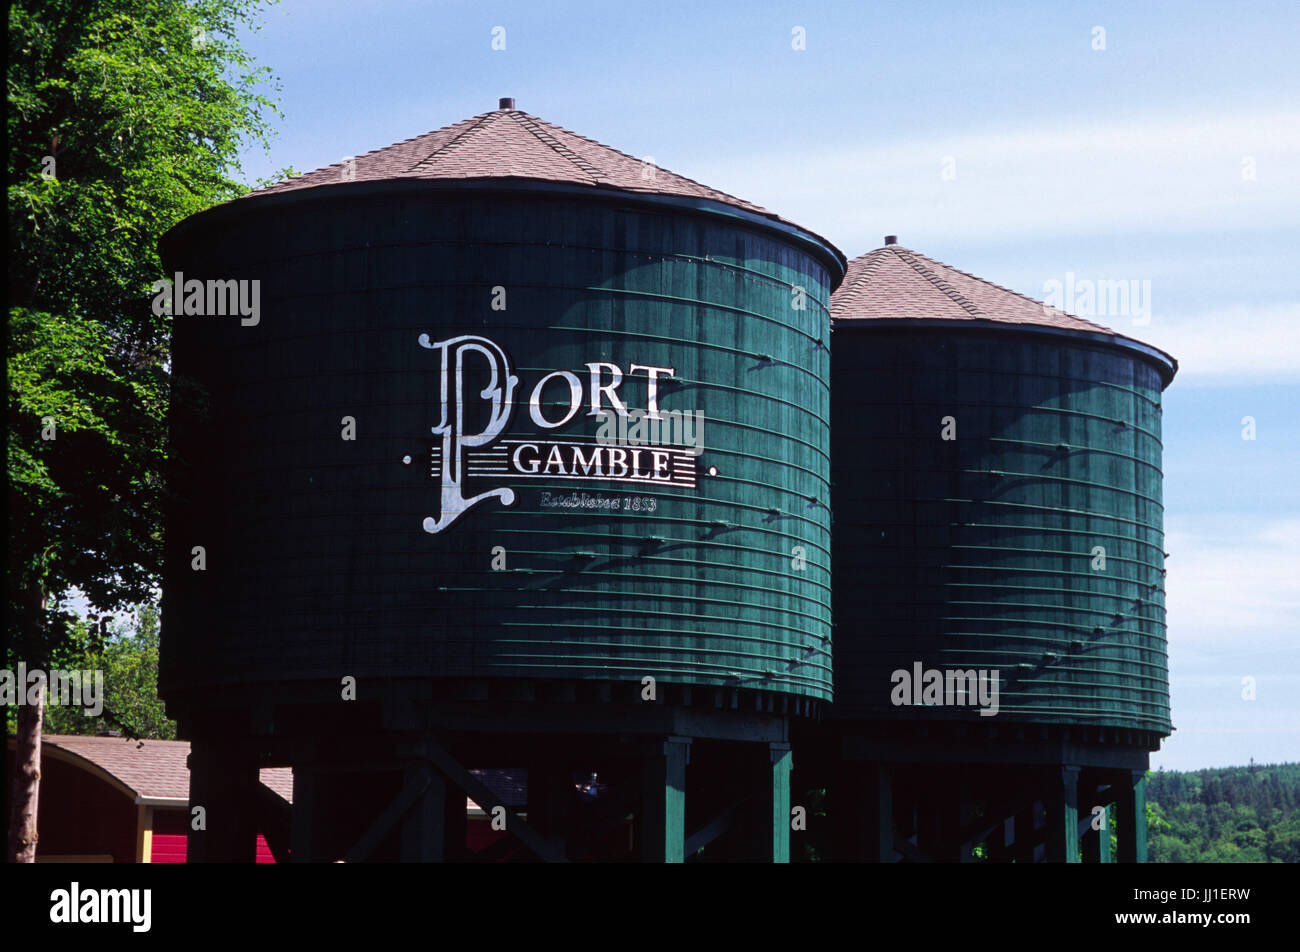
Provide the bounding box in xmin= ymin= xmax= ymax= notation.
xmin=692 ymin=113 xmax=1300 ymax=254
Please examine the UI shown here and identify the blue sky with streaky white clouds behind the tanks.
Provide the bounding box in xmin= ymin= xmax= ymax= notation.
xmin=226 ymin=0 xmax=1300 ymax=770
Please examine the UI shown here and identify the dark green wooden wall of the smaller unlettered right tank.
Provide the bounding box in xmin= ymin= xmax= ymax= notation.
xmin=832 ymin=329 xmax=1170 ymax=734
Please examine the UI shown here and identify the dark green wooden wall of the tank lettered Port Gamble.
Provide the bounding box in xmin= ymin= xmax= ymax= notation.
xmin=163 ymin=189 xmax=837 ymax=700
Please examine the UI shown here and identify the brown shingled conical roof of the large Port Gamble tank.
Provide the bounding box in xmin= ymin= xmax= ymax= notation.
xmin=249 ymin=103 xmax=781 ymax=221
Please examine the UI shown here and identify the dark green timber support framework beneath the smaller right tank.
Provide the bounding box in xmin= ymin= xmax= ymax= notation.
xmin=796 ymin=722 xmax=1158 ymax=862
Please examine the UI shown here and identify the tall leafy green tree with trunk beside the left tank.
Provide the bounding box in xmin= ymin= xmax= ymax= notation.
xmin=5 ymin=0 xmax=277 ymax=861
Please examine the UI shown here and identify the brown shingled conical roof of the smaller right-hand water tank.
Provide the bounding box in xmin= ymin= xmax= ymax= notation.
xmin=831 ymin=245 xmax=1117 ymax=337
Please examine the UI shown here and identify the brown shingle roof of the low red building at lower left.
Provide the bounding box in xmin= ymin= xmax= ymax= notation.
xmin=32 ymin=734 xmax=294 ymax=802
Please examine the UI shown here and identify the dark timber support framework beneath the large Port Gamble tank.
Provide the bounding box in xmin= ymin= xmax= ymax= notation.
xmin=185 ymin=681 xmax=816 ymax=862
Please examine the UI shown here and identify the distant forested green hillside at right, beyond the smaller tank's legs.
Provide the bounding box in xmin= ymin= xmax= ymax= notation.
xmin=1147 ymin=763 xmax=1300 ymax=862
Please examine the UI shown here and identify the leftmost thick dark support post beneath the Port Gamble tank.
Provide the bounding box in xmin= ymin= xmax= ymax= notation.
xmin=187 ymin=737 xmax=259 ymax=862
